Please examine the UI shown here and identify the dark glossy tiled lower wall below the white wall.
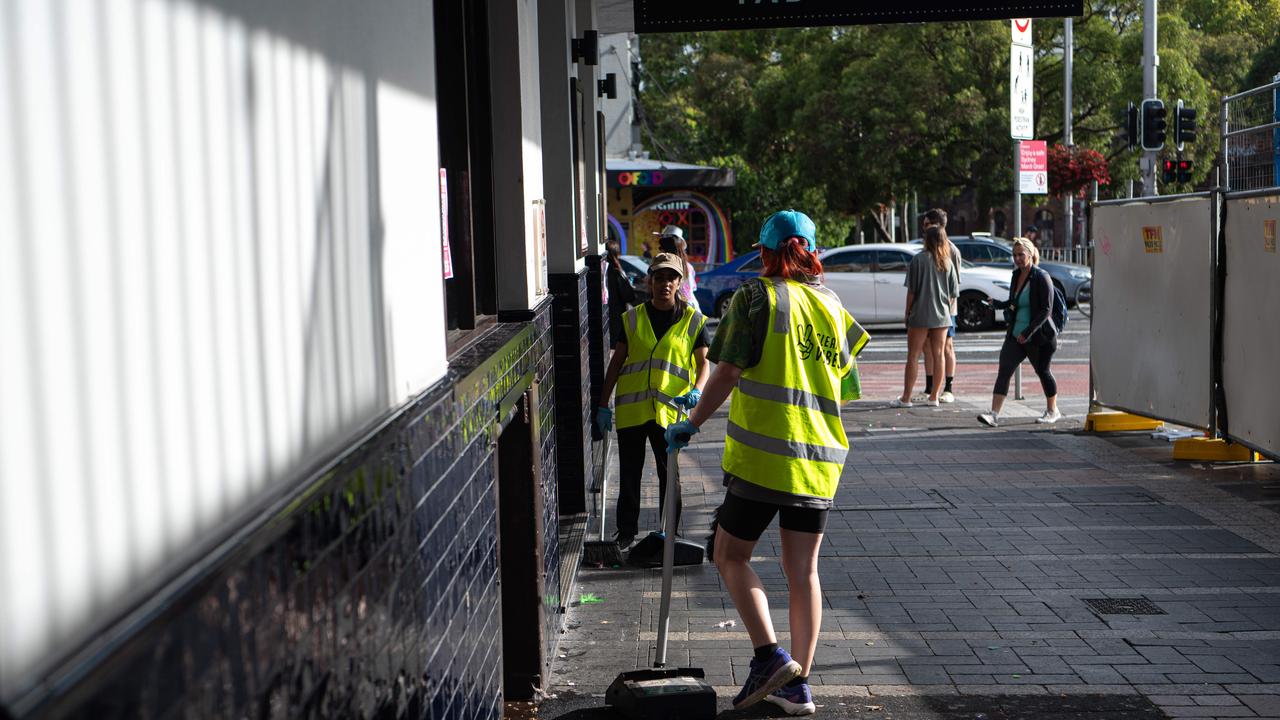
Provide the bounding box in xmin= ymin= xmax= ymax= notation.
xmin=10 ymin=297 xmax=560 ymax=720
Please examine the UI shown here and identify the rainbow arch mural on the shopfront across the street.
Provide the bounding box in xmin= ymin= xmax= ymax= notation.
xmin=609 ymin=190 xmax=733 ymax=265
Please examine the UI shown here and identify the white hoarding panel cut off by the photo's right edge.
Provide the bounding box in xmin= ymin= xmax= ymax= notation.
xmin=1222 ymin=195 xmax=1280 ymax=457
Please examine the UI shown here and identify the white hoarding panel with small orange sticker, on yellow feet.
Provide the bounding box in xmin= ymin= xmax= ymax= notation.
xmin=1089 ymin=197 xmax=1212 ymax=429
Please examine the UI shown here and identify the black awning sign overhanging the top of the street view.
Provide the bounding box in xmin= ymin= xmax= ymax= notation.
xmin=635 ymin=0 xmax=1084 ymax=32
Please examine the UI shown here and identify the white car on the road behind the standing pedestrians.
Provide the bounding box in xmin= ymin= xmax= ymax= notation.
xmin=818 ymin=242 xmax=1009 ymax=331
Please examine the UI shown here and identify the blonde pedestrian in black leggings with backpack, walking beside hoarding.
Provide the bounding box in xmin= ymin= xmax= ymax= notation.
xmin=978 ymin=237 xmax=1066 ymax=428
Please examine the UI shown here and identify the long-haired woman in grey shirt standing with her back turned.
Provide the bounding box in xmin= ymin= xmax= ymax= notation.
xmin=890 ymin=225 xmax=960 ymax=407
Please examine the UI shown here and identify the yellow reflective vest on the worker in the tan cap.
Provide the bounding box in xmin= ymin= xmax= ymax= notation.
xmin=613 ymin=305 xmax=707 ymax=428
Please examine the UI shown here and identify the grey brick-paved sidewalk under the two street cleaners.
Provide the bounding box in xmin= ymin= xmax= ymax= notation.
xmin=529 ymin=384 xmax=1280 ymax=720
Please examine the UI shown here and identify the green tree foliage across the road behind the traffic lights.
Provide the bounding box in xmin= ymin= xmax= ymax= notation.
xmin=639 ymin=0 xmax=1280 ymax=226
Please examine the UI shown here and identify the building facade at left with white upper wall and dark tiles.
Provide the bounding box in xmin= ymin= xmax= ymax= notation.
xmin=0 ymin=0 xmax=608 ymax=719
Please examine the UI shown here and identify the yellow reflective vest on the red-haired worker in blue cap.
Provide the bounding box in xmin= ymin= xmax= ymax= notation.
xmin=723 ymin=278 xmax=868 ymax=500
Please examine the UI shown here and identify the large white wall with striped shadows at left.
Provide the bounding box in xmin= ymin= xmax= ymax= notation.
xmin=0 ymin=0 xmax=450 ymax=694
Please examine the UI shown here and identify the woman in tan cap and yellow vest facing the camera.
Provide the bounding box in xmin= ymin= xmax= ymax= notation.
xmin=595 ymin=252 xmax=708 ymax=548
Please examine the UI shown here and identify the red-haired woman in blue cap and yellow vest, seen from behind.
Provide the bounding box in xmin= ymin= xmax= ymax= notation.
xmin=667 ymin=210 xmax=868 ymax=715
